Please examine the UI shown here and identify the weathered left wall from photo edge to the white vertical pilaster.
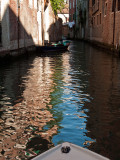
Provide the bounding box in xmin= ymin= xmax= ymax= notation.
xmin=0 ymin=0 xmax=38 ymax=50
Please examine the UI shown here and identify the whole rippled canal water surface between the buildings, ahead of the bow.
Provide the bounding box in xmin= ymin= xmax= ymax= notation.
xmin=0 ymin=41 xmax=120 ymax=160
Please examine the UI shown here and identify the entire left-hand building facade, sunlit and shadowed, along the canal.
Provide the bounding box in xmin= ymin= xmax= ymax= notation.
xmin=0 ymin=0 xmax=62 ymax=55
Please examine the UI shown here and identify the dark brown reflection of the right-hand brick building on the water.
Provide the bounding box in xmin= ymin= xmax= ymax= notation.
xmin=86 ymin=49 xmax=120 ymax=160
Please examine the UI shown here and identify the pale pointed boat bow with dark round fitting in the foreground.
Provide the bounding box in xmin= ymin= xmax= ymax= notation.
xmin=33 ymin=142 xmax=109 ymax=160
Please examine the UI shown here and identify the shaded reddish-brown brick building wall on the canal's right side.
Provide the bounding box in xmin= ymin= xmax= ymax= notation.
xmin=86 ymin=0 xmax=120 ymax=47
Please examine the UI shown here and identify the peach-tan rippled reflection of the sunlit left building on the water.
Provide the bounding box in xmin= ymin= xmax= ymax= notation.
xmin=0 ymin=57 xmax=57 ymax=159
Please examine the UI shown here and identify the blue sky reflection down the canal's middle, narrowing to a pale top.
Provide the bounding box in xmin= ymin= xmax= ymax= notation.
xmin=52 ymin=54 xmax=93 ymax=147
